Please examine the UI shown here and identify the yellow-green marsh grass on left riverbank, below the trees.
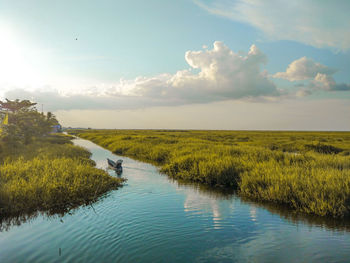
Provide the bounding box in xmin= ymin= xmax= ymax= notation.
xmin=0 ymin=135 xmax=123 ymax=219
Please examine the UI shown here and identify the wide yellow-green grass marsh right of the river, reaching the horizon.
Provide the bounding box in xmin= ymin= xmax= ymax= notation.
xmin=73 ymin=130 xmax=350 ymax=217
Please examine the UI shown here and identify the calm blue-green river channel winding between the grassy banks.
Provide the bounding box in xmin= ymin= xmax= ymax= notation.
xmin=0 ymin=139 xmax=350 ymax=262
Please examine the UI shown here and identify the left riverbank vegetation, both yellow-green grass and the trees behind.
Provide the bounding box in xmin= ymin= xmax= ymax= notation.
xmin=0 ymin=101 xmax=123 ymax=221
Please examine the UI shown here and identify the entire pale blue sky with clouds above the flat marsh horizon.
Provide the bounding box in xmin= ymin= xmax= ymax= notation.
xmin=0 ymin=0 xmax=350 ymax=131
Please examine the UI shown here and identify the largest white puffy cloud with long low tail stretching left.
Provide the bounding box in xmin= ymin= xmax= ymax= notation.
xmin=5 ymin=41 xmax=281 ymax=110
